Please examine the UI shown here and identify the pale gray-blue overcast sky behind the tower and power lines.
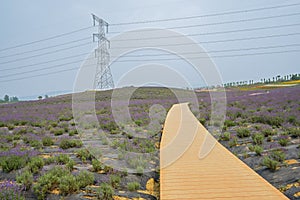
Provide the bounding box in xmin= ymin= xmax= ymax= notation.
xmin=0 ymin=0 xmax=300 ymax=99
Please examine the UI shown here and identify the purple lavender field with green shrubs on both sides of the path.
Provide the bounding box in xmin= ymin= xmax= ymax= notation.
xmin=0 ymin=86 xmax=300 ymax=200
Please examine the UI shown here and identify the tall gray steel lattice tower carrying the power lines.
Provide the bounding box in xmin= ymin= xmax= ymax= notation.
xmin=92 ymin=14 xmax=114 ymax=89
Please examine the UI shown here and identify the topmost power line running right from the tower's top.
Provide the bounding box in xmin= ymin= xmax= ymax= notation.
xmin=110 ymin=3 xmax=300 ymax=26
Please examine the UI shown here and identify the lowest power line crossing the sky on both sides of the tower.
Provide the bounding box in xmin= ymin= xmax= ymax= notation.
xmin=0 ymin=49 xmax=300 ymax=83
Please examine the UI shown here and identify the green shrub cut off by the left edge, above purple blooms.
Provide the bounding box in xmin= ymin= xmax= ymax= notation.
xmin=1 ymin=155 xmax=27 ymax=173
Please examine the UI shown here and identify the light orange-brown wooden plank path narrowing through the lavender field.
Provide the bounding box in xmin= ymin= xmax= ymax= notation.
xmin=160 ymin=104 xmax=288 ymax=200
